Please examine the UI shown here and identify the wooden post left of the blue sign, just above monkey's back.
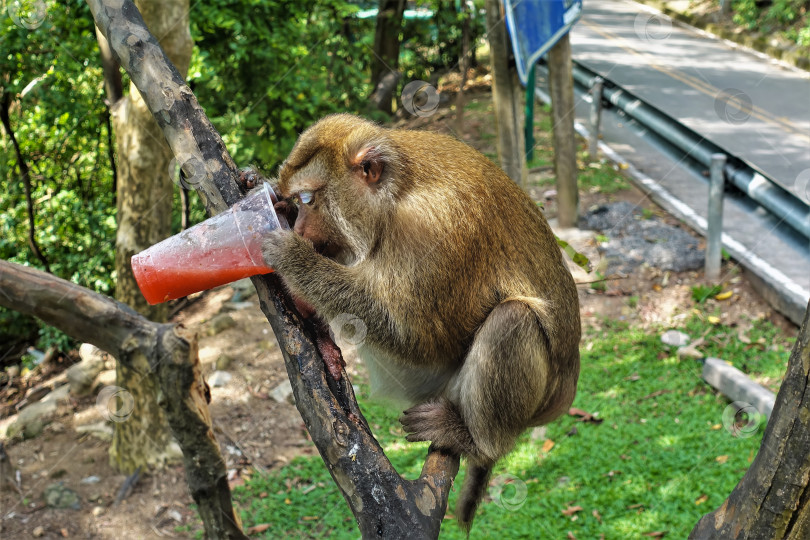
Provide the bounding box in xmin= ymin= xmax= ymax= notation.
xmin=486 ymin=0 xmax=528 ymax=189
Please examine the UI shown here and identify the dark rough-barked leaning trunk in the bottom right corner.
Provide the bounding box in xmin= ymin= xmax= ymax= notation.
xmin=689 ymin=298 xmax=810 ymax=540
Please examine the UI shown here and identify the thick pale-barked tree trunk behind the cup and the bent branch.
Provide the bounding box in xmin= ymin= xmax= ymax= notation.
xmin=110 ymin=0 xmax=192 ymax=474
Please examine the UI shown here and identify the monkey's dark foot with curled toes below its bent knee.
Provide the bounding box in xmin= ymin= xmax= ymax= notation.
xmin=399 ymin=399 xmax=475 ymax=455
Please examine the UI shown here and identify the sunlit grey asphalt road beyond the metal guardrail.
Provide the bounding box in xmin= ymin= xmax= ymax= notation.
xmin=571 ymin=0 xmax=810 ymax=202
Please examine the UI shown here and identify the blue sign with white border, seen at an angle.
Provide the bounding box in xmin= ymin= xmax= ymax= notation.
xmin=503 ymin=0 xmax=582 ymax=85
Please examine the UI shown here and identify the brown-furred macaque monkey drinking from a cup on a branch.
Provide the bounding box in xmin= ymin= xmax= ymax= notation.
xmin=256 ymin=114 xmax=580 ymax=530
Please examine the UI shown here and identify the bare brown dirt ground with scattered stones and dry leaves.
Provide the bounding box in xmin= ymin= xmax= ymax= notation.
xmin=0 ymin=86 xmax=796 ymax=539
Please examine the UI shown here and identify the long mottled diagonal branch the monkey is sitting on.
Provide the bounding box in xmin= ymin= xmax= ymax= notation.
xmin=88 ymin=0 xmax=459 ymax=538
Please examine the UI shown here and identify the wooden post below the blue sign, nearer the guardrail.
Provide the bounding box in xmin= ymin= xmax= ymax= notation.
xmin=548 ymin=34 xmax=579 ymax=227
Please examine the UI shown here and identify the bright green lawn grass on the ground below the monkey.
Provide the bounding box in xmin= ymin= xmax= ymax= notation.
xmin=235 ymin=315 xmax=791 ymax=539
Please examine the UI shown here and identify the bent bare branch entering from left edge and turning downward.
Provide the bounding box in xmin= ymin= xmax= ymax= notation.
xmin=0 ymin=260 xmax=246 ymax=538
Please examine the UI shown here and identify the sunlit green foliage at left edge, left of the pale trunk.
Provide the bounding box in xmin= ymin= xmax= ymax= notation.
xmin=0 ymin=0 xmax=115 ymax=348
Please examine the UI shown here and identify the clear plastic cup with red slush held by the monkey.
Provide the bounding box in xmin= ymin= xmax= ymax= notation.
xmin=131 ymin=184 xmax=289 ymax=305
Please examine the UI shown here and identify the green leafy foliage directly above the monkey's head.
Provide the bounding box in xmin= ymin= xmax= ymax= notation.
xmin=189 ymin=0 xmax=374 ymax=172
